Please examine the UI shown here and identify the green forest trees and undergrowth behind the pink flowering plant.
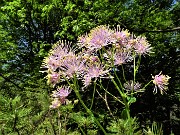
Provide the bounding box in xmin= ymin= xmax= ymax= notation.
xmin=0 ymin=0 xmax=180 ymax=135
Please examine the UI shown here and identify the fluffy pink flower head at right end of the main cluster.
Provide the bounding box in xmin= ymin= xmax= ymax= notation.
xmin=134 ymin=36 xmax=152 ymax=55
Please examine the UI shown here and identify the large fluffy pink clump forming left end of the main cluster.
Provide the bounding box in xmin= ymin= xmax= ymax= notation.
xmin=43 ymin=41 xmax=79 ymax=82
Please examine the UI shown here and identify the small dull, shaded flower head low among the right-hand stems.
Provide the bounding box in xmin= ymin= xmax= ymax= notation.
xmin=124 ymin=80 xmax=141 ymax=91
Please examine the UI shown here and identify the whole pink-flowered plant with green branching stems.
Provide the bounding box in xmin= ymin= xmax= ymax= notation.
xmin=40 ymin=26 xmax=170 ymax=133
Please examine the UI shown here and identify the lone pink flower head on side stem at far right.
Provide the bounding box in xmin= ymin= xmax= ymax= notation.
xmin=152 ymin=72 xmax=171 ymax=95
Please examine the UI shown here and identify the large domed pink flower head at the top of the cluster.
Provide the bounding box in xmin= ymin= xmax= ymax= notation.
xmin=86 ymin=26 xmax=112 ymax=50
